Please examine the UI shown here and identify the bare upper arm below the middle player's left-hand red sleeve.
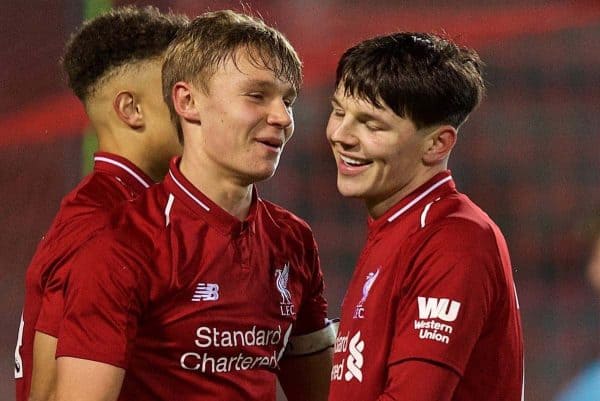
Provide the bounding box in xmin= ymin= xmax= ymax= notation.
xmin=56 ymin=357 xmax=125 ymax=401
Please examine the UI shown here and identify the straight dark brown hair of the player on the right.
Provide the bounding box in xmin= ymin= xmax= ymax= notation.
xmin=335 ymin=32 xmax=485 ymax=128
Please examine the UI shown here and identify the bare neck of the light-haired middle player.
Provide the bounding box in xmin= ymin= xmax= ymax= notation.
xmin=179 ymin=155 xmax=253 ymax=221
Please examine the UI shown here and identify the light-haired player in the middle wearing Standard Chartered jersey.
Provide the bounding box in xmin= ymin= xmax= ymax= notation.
xmin=57 ymin=11 xmax=334 ymax=401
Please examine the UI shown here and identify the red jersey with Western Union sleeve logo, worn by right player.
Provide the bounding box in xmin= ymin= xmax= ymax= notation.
xmin=329 ymin=171 xmax=523 ymax=401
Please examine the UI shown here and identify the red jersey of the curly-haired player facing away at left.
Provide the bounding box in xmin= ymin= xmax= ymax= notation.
xmin=15 ymin=152 xmax=152 ymax=401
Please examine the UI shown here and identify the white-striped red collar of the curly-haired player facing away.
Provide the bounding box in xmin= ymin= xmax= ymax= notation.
xmin=94 ymin=152 xmax=154 ymax=191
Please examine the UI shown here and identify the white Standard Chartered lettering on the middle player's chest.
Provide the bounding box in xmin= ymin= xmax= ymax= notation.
xmin=180 ymin=325 xmax=282 ymax=373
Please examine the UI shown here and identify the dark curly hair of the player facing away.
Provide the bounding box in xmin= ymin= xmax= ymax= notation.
xmin=61 ymin=6 xmax=188 ymax=102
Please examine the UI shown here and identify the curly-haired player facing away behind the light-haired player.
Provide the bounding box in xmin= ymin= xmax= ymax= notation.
xmin=15 ymin=7 xmax=187 ymax=401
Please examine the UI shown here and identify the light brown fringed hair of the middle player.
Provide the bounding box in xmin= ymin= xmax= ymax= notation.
xmin=162 ymin=10 xmax=302 ymax=143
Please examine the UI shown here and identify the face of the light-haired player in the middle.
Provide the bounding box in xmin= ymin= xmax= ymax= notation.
xmin=183 ymin=46 xmax=296 ymax=184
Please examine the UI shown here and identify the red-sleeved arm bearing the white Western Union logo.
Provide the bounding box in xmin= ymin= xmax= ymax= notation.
xmin=379 ymin=222 xmax=497 ymax=401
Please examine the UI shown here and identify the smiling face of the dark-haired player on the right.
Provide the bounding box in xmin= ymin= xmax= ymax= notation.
xmin=327 ymin=88 xmax=427 ymax=215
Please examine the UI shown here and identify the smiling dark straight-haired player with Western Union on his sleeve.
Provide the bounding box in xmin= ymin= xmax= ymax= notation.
xmin=327 ymin=32 xmax=523 ymax=401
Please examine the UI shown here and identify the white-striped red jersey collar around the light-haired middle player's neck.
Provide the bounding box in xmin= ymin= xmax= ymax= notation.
xmin=163 ymin=157 xmax=259 ymax=235
